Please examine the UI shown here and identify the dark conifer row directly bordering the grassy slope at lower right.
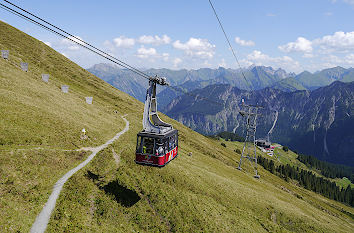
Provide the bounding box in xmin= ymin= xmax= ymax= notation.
xmin=257 ymin=156 xmax=354 ymax=207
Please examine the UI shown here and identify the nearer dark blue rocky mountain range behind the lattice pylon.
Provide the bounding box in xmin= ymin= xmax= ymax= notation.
xmin=163 ymin=81 xmax=354 ymax=166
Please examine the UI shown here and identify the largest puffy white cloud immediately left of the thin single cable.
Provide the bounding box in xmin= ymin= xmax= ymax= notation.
xmin=172 ymin=37 xmax=215 ymax=59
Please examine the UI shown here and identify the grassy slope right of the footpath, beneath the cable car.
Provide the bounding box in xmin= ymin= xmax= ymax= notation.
xmin=48 ymin=117 xmax=353 ymax=232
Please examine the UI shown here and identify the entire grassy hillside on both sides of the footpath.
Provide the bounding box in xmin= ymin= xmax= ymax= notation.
xmin=0 ymin=20 xmax=354 ymax=232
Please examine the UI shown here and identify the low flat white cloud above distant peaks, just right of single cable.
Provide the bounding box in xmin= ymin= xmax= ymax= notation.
xmin=242 ymin=50 xmax=302 ymax=72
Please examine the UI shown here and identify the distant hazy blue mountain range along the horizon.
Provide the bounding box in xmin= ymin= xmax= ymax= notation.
xmin=88 ymin=63 xmax=354 ymax=107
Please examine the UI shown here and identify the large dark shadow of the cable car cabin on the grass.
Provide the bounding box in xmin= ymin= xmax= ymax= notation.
xmin=103 ymin=180 xmax=140 ymax=207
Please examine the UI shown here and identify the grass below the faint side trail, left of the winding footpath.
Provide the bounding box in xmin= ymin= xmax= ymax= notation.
xmin=0 ymin=150 xmax=87 ymax=232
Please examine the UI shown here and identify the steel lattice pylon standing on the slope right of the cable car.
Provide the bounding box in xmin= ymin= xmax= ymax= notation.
xmin=237 ymin=99 xmax=262 ymax=179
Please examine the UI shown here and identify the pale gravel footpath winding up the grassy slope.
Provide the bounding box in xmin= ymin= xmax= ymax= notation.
xmin=31 ymin=115 xmax=129 ymax=233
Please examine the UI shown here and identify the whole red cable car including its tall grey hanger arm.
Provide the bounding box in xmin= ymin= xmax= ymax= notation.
xmin=135 ymin=76 xmax=178 ymax=167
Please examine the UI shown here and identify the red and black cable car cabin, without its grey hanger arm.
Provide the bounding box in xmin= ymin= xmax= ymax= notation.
xmin=135 ymin=129 xmax=178 ymax=167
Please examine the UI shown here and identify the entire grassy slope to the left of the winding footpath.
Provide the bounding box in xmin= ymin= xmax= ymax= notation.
xmin=0 ymin=22 xmax=136 ymax=232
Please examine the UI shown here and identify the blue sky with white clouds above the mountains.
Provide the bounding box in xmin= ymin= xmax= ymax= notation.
xmin=0 ymin=0 xmax=354 ymax=73
